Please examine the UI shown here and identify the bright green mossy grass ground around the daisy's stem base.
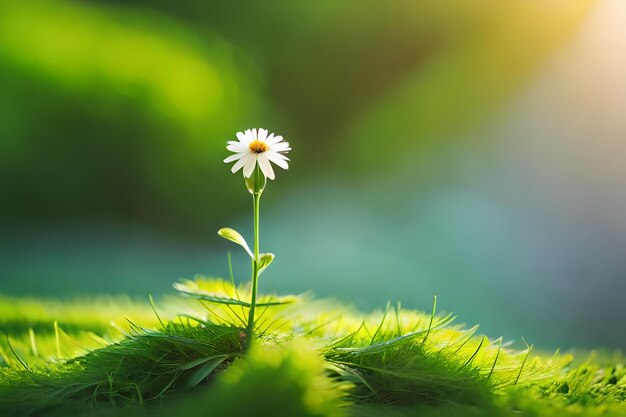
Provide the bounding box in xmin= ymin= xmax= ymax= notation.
xmin=0 ymin=278 xmax=626 ymax=417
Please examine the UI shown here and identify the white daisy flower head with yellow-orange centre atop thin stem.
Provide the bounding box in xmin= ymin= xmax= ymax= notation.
xmin=224 ymin=129 xmax=291 ymax=180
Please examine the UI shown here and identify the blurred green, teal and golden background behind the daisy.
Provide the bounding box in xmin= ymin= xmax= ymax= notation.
xmin=0 ymin=0 xmax=626 ymax=348
